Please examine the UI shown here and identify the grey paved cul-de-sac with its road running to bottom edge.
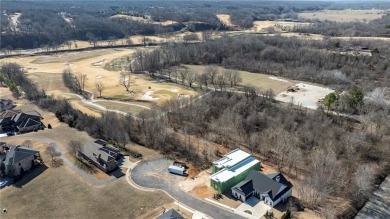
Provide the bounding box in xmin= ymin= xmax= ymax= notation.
xmin=130 ymin=158 xmax=244 ymax=219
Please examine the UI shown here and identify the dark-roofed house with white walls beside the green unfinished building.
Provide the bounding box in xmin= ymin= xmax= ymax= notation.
xmin=231 ymin=171 xmax=293 ymax=207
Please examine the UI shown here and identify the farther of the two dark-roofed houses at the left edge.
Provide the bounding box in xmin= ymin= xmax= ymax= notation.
xmin=0 ymin=110 xmax=43 ymax=132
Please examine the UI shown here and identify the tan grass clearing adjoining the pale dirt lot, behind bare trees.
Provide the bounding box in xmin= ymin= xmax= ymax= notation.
xmin=184 ymin=65 xmax=295 ymax=94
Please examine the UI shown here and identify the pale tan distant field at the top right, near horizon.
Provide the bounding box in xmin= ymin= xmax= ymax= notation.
xmin=298 ymin=9 xmax=385 ymax=22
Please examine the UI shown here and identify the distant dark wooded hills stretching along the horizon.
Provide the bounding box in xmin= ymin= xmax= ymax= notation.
xmin=0 ymin=1 xmax=389 ymax=50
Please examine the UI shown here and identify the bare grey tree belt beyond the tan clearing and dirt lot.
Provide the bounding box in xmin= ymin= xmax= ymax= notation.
xmin=135 ymin=36 xmax=390 ymax=91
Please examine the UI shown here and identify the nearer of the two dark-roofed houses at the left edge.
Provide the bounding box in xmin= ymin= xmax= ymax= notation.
xmin=0 ymin=144 xmax=40 ymax=177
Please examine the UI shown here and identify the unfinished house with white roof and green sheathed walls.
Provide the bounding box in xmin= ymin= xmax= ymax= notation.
xmin=210 ymin=148 xmax=260 ymax=193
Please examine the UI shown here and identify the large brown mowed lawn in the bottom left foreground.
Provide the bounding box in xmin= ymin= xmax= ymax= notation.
xmin=0 ymin=166 xmax=173 ymax=219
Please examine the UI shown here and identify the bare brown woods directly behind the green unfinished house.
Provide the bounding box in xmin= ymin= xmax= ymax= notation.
xmin=156 ymin=92 xmax=390 ymax=218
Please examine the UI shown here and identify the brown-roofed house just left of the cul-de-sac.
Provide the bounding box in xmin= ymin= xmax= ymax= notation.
xmin=79 ymin=140 xmax=119 ymax=173
